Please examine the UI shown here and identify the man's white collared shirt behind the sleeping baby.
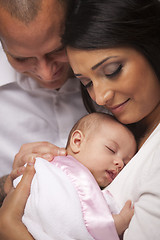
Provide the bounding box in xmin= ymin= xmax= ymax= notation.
xmin=0 ymin=46 xmax=87 ymax=176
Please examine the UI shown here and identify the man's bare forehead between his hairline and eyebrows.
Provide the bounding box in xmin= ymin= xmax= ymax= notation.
xmin=0 ymin=3 xmax=65 ymax=45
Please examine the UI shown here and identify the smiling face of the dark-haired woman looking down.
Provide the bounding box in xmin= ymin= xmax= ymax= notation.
xmin=67 ymin=47 xmax=160 ymax=124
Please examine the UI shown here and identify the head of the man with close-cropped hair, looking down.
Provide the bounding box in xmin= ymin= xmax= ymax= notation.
xmin=0 ymin=0 xmax=72 ymax=89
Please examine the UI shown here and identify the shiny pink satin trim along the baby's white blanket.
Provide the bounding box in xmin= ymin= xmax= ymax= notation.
xmin=52 ymin=156 xmax=119 ymax=240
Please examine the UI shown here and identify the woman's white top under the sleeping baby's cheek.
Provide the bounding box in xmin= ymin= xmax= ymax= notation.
xmin=108 ymin=124 xmax=160 ymax=240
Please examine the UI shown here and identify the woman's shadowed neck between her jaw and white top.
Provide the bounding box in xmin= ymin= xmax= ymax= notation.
xmin=127 ymin=103 xmax=160 ymax=149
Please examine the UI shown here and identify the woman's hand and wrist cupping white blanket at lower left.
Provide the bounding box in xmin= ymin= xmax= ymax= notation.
xmin=0 ymin=159 xmax=35 ymax=240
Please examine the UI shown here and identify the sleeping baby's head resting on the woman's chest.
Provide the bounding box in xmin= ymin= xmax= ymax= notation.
xmin=67 ymin=113 xmax=137 ymax=188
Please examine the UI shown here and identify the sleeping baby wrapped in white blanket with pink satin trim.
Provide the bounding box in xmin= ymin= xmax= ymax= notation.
xmin=14 ymin=113 xmax=136 ymax=240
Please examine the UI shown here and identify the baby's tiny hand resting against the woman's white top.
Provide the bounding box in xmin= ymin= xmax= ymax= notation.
xmin=113 ymin=200 xmax=134 ymax=235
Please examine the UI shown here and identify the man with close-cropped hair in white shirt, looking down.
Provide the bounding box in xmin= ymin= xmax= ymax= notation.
xmin=0 ymin=0 xmax=87 ymax=204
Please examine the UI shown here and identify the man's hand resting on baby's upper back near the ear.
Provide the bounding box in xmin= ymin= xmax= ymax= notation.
xmin=4 ymin=142 xmax=66 ymax=194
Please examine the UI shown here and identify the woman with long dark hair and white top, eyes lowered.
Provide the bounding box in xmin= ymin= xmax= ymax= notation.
xmin=0 ymin=0 xmax=160 ymax=240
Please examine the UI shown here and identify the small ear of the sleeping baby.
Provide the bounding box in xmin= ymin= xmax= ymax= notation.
xmin=70 ymin=130 xmax=84 ymax=153
